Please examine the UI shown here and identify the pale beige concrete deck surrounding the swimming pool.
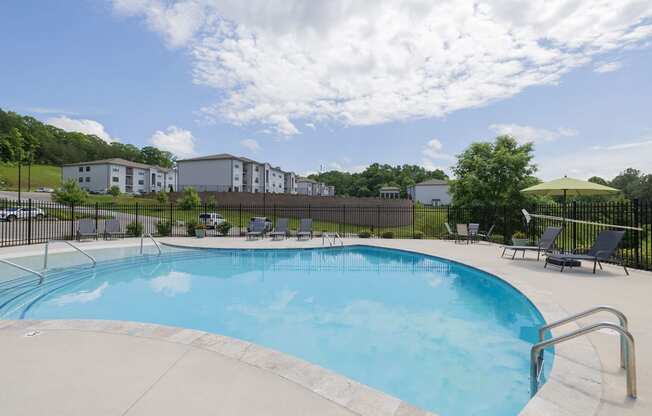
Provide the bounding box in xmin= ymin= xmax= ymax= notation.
xmin=0 ymin=238 xmax=652 ymax=416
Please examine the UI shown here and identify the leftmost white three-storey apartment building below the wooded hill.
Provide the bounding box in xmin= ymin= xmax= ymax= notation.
xmin=61 ymin=158 xmax=177 ymax=194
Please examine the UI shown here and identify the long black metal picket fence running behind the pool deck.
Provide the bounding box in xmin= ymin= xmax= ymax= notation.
xmin=0 ymin=199 xmax=652 ymax=270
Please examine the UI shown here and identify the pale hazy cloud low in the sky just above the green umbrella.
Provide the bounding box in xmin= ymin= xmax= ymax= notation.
xmin=537 ymin=138 xmax=652 ymax=180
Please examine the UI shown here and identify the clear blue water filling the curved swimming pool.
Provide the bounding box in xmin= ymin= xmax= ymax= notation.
xmin=0 ymin=246 xmax=543 ymax=416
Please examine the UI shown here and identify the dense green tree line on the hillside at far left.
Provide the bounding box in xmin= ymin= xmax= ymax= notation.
xmin=0 ymin=109 xmax=174 ymax=167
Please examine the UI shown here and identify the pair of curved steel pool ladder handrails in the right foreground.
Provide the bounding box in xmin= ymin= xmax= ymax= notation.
xmin=530 ymin=305 xmax=636 ymax=399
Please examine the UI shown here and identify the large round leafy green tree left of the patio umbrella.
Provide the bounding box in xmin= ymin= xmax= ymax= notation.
xmin=450 ymin=136 xmax=538 ymax=206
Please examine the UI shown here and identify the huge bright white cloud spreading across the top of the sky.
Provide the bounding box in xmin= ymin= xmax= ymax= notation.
xmin=113 ymin=0 xmax=652 ymax=135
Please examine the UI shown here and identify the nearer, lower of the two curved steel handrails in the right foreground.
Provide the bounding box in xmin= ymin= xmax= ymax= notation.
xmin=530 ymin=322 xmax=636 ymax=399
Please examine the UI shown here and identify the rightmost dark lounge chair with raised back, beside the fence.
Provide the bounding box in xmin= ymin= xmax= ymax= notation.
xmin=544 ymin=230 xmax=629 ymax=276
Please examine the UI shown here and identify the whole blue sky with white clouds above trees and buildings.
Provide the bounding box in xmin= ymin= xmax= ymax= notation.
xmin=0 ymin=0 xmax=652 ymax=179
